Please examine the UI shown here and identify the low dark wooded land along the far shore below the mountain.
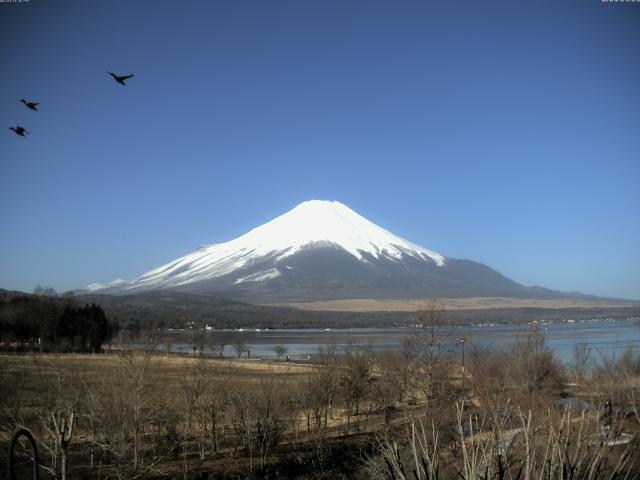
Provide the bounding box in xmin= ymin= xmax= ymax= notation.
xmin=0 ymin=289 xmax=640 ymax=328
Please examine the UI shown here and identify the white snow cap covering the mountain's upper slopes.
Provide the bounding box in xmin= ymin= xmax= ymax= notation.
xmin=86 ymin=200 xmax=445 ymax=292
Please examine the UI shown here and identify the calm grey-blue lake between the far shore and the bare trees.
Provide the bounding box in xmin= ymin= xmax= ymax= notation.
xmin=161 ymin=319 xmax=640 ymax=363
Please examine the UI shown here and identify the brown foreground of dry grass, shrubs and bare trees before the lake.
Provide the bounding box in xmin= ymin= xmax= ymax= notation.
xmin=0 ymin=307 xmax=640 ymax=480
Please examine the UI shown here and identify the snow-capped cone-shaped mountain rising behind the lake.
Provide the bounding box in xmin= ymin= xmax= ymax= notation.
xmin=81 ymin=200 xmax=567 ymax=303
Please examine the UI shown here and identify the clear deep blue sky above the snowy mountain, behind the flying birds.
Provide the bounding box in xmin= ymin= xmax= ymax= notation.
xmin=0 ymin=0 xmax=640 ymax=299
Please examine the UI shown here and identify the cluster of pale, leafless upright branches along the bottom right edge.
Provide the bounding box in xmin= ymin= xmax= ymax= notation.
xmin=371 ymin=404 xmax=637 ymax=480
